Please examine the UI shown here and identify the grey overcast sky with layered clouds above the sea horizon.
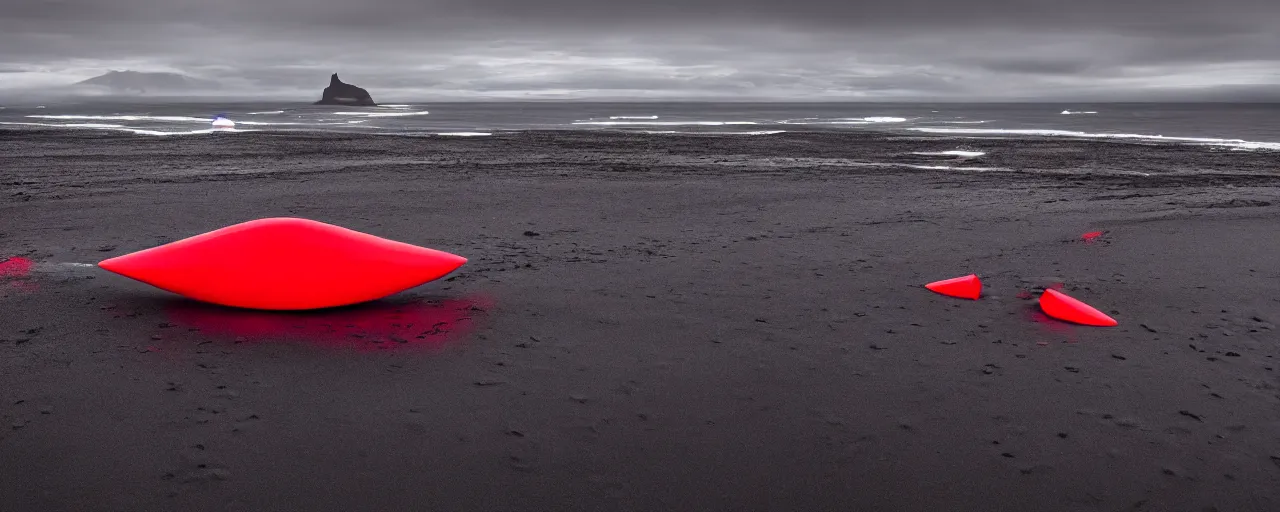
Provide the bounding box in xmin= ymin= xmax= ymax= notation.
xmin=0 ymin=0 xmax=1280 ymax=101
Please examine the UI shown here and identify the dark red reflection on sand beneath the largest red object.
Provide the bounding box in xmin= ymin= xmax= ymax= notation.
xmin=165 ymin=297 xmax=492 ymax=349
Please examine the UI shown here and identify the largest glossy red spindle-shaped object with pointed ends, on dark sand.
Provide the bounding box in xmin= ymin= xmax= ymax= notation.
xmin=99 ymin=218 xmax=467 ymax=310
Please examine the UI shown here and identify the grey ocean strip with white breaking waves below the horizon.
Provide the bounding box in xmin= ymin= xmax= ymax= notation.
xmin=0 ymin=102 xmax=1280 ymax=151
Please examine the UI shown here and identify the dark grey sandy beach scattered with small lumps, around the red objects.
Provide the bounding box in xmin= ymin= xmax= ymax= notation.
xmin=0 ymin=132 xmax=1280 ymax=511
